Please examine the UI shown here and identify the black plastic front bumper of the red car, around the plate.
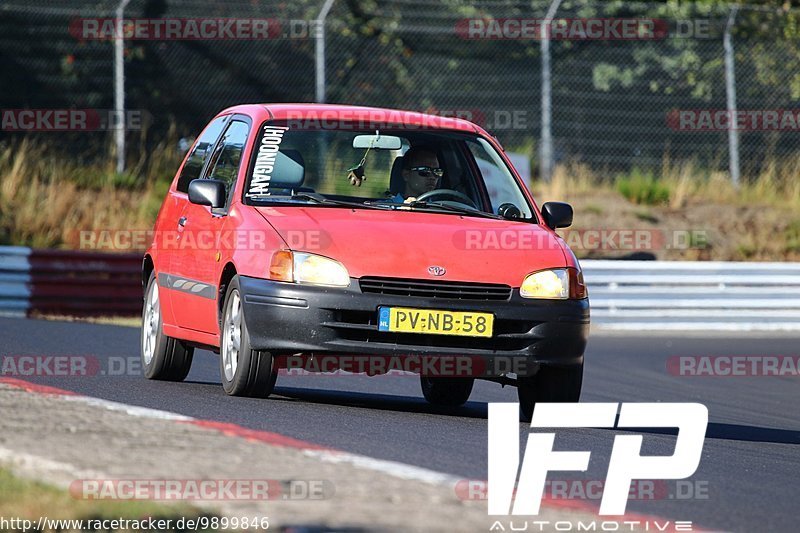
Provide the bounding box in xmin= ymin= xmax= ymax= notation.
xmin=239 ymin=276 xmax=589 ymax=366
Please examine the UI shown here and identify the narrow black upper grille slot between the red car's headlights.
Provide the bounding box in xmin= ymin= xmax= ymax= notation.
xmin=359 ymin=277 xmax=511 ymax=301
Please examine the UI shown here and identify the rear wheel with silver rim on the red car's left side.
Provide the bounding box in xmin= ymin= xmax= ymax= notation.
xmin=139 ymin=273 xmax=194 ymax=381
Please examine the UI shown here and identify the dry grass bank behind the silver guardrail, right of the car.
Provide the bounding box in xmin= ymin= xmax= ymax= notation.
xmin=533 ymin=156 xmax=800 ymax=261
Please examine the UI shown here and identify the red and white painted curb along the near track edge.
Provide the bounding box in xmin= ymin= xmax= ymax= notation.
xmin=0 ymin=377 xmax=707 ymax=532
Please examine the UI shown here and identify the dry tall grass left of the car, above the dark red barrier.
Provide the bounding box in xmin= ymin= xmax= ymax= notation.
xmin=0 ymin=135 xmax=180 ymax=247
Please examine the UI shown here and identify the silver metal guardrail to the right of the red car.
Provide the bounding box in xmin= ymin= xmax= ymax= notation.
xmin=581 ymin=260 xmax=800 ymax=331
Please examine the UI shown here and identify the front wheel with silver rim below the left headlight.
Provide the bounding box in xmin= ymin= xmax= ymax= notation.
xmin=219 ymin=276 xmax=278 ymax=398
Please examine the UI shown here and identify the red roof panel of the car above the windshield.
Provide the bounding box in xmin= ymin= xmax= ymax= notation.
xmin=217 ymin=103 xmax=483 ymax=133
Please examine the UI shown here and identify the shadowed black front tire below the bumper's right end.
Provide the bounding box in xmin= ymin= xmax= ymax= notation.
xmin=517 ymin=363 xmax=583 ymax=422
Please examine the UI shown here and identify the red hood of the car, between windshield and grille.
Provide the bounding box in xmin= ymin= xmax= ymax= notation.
xmin=254 ymin=206 xmax=566 ymax=287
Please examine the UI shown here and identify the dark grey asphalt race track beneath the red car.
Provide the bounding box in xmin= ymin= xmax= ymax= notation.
xmin=0 ymin=318 xmax=800 ymax=532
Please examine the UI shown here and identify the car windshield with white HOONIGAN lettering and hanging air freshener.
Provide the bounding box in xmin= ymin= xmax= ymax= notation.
xmin=244 ymin=122 xmax=533 ymax=220
